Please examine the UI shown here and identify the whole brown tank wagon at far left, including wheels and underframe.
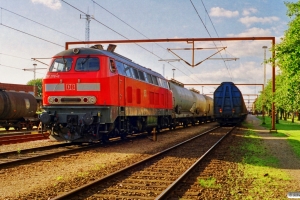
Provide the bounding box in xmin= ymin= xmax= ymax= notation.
xmin=0 ymin=90 xmax=39 ymax=130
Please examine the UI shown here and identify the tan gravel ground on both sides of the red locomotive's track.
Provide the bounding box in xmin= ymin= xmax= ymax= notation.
xmin=0 ymin=123 xmax=216 ymax=200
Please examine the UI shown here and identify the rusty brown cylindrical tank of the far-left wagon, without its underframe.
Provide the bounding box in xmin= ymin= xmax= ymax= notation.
xmin=0 ymin=90 xmax=37 ymax=120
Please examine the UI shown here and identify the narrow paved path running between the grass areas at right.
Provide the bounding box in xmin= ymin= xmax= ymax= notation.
xmin=246 ymin=115 xmax=300 ymax=190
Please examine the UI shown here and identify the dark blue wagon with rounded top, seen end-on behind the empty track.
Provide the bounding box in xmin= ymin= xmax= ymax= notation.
xmin=213 ymin=82 xmax=248 ymax=126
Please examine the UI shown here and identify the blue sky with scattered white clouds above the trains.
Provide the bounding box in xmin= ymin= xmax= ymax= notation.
xmin=0 ymin=0 xmax=297 ymax=108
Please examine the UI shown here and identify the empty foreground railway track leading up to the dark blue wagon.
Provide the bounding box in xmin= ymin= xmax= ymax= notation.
xmin=53 ymin=127 xmax=234 ymax=200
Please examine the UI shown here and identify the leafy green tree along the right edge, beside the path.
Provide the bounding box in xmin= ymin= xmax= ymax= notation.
xmin=274 ymin=1 xmax=300 ymax=120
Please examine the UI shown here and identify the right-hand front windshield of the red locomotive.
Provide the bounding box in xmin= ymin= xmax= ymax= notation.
xmin=75 ymin=56 xmax=100 ymax=71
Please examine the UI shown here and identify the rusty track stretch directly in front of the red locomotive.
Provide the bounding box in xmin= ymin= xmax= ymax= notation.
xmin=0 ymin=143 xmax=97 ymax=168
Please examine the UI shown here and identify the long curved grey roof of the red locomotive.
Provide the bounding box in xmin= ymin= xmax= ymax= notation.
xmin=54 ymin=48 xmax=165 ymax=79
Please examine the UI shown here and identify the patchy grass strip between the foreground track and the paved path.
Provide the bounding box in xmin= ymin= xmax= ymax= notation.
xmin=228 ymin=123 xmax=292 ymax=199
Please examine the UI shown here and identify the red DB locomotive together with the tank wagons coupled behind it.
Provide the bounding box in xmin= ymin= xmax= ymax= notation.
xmin=40 ymin=45 xmax=212 ymax=142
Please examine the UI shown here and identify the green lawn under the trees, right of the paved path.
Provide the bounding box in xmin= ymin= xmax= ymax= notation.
xmin=258 ymin=116 xmax=300 ymax=158
